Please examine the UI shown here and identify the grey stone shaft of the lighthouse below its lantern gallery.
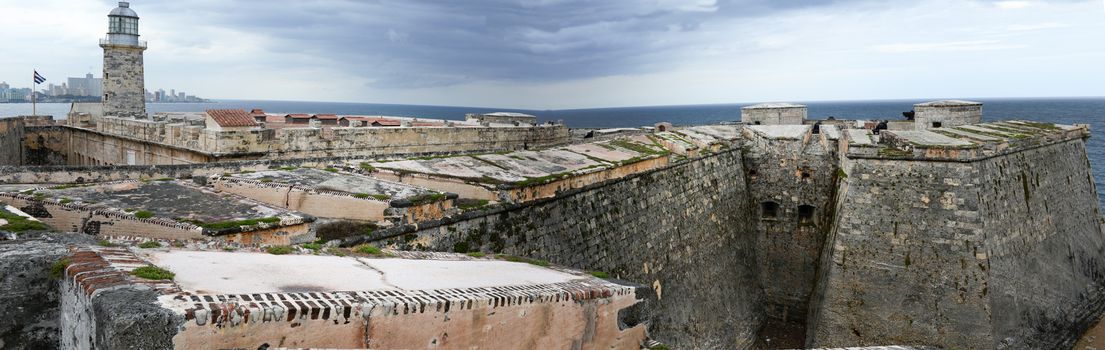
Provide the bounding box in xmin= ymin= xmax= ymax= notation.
xmin=103 ymin=44 xmax=147 ymax=118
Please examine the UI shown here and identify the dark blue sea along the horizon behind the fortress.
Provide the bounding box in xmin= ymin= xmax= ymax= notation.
xmin=0 ymin=97 xmax=1105 ymax=203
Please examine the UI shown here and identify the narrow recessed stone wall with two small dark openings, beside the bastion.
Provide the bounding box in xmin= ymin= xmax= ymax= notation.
xmin=744 ymin=129 xmax=838 ymax=324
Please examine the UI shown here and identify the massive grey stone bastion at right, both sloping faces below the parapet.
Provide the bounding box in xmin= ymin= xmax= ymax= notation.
xmin=807 ymin=139 xmax=1105 ymax=349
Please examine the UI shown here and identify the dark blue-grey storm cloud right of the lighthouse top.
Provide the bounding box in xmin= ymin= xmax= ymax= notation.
xmin=140 ymin=0 xmax=834 ymax=87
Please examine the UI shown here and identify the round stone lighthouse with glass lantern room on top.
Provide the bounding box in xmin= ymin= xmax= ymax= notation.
xmin=99 ymin=1 xmax=147 ymax=119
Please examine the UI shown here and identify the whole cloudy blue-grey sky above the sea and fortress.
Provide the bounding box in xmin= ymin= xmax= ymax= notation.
xmin=0 ymin=0 xmax=1105 ymax=109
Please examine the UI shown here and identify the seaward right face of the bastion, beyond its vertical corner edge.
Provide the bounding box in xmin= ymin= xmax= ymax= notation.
xmin=979 ymin=139 xmax=1105 ymax=349
